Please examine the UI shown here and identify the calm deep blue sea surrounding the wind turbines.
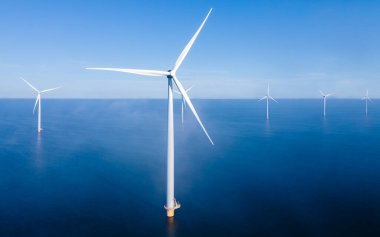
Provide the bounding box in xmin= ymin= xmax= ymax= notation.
xmin=0 ymin=99 xmax=380 ymax=237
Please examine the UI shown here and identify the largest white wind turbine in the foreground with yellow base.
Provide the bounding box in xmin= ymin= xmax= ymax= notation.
xmin=87 ymin=9 xmax=214 ymax=217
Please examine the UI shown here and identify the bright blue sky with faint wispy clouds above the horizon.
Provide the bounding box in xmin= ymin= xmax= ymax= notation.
xmin=0 ymin=0 xmax=380 ymax=98
